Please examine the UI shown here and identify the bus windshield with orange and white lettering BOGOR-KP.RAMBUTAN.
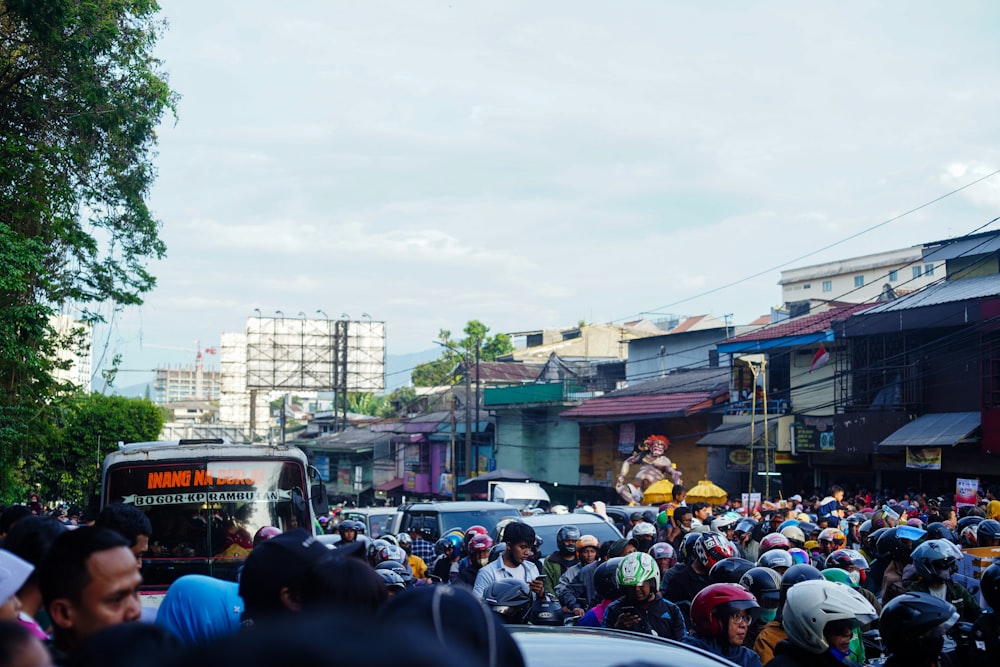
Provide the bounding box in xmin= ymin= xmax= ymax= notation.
xmin=104 ymin=459 xmax=311 ymax=587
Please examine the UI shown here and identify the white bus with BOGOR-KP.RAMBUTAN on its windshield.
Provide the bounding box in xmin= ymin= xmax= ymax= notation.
xmin=101 ymin=440 xmax=329 ymax=592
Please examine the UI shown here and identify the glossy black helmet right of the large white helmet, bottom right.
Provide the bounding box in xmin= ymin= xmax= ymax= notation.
xmin=879 ymin=592 xmax=958 ymax=656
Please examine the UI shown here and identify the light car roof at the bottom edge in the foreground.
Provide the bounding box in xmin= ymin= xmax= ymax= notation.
xmin=506 ymin=625 xmax=733 ymax=667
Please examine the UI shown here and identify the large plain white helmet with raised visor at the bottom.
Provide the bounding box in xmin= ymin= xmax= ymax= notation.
xmin=781 ymin=580 xmax=878 ymax=655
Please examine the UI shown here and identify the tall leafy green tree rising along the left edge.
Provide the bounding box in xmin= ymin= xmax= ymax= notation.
xmin=0 ymin=0 xmax=176 ymax=490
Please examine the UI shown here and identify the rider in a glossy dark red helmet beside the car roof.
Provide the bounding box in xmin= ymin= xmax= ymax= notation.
xmin=682 ymin=583 xmax=761 ymax=667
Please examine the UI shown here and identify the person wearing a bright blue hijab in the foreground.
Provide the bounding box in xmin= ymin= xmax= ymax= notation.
xmin=156 ymin=574 xmax=243 ymax=644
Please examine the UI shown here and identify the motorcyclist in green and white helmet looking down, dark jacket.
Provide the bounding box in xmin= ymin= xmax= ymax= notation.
xmin=602 ymin=552 xmax=687 ymax=639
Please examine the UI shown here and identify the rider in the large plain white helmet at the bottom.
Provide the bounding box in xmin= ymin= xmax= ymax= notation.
xmin=767 ymin=580 xmax=877 ymax=667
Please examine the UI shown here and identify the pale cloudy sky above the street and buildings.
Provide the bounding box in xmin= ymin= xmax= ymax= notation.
xmin=86 ymin=0 xmax=1000 ymax=389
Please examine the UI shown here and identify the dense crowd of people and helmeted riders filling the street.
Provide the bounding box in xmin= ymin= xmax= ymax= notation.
xmin=0 ymin=485 xmax=1000 ymax=667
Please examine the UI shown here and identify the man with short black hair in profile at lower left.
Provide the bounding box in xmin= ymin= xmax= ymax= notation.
xmin=38 ymin=526 xmax=142 ymax=665
